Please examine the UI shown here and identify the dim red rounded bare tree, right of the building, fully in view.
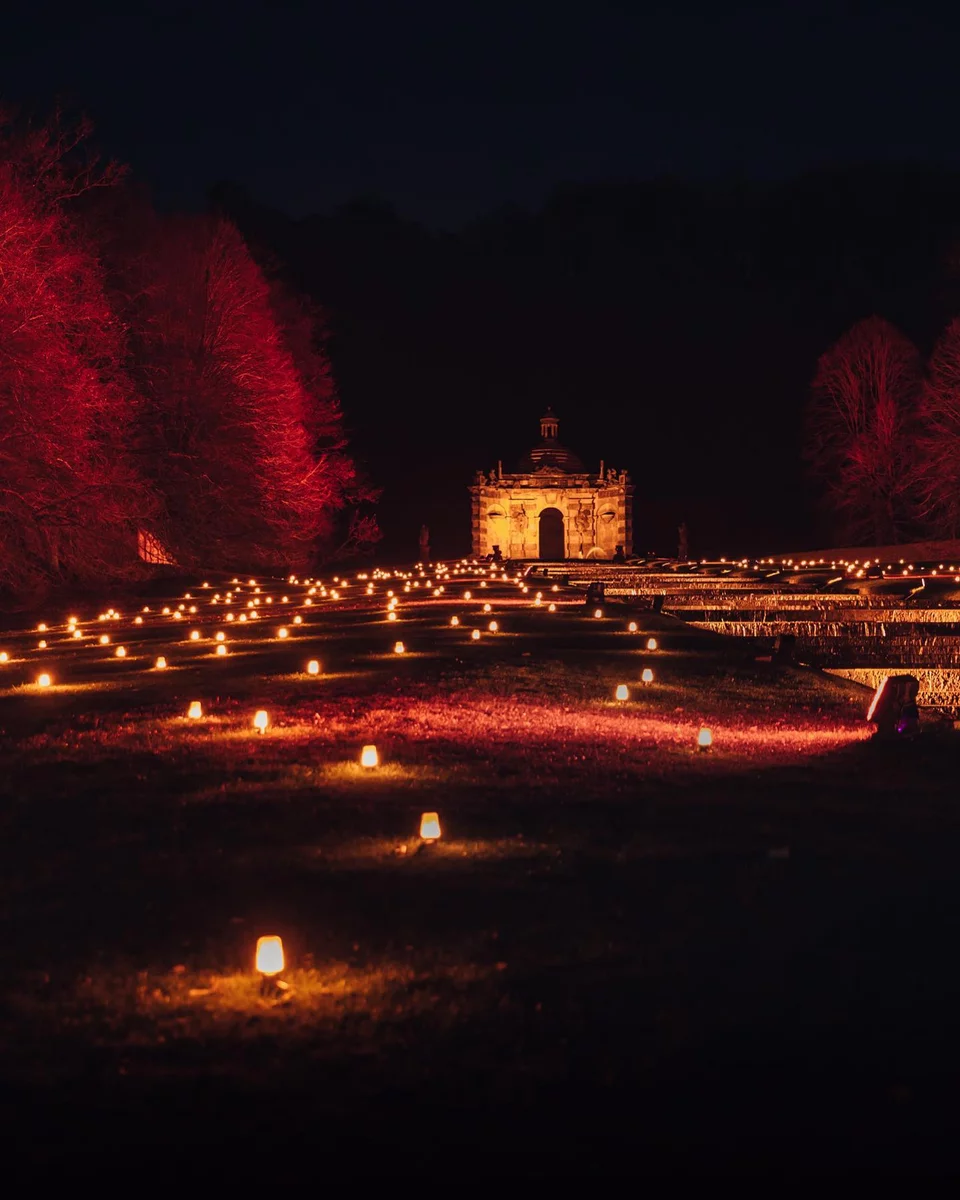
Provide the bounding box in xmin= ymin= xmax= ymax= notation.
xmin=806 ymin=317 xmax=920 ymax=545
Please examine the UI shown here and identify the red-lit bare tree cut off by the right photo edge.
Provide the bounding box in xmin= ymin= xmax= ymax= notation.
xmin=917 ymin=317 xmax=960 ymax=538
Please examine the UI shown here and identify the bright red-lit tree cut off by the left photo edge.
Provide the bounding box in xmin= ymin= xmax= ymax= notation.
xmin=0 ymin=114 xmax=152 ymax=593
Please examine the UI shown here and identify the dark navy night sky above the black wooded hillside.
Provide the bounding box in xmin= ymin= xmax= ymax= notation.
xmin=0 ymin=0 xmax=960 ymax=227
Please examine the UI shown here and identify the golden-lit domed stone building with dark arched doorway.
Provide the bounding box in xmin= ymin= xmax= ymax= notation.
xmin=470 ymin=409 xmax=634 ymax=562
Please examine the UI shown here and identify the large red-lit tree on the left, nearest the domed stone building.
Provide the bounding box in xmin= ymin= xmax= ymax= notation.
xmin=126 ymin=217 xmax=354 ymax=568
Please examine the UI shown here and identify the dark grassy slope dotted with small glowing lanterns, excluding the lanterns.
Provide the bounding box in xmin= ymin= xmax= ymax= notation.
xmin=0 ymin=566 xmax=960 ymax=1187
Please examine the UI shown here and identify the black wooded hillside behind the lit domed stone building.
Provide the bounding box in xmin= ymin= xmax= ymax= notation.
xmin=214 ymin=167 xmax=960 ymax=556
